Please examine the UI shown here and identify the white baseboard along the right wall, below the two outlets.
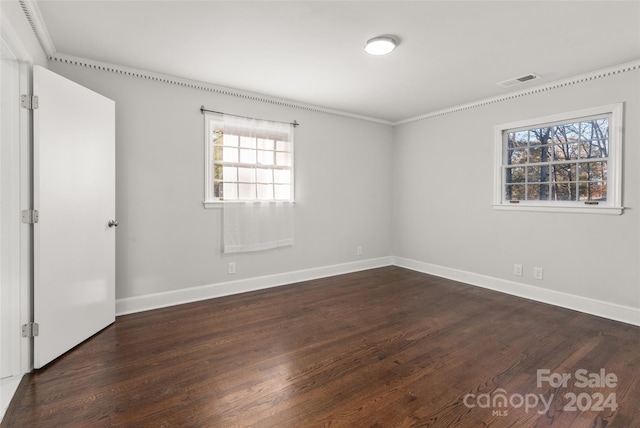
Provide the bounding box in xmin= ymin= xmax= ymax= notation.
xmin=392 ymin=257 xmax=640 ymax=326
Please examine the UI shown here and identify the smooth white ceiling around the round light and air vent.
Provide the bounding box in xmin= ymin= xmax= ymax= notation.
xmin=36 ymin=0 xmax=640 ymax=122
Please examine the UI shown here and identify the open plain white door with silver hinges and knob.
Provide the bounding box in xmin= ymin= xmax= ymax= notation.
xmin=33 ymin=66 xmax=116 ymax=368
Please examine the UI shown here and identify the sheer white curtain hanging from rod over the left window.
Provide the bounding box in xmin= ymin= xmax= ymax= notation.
xmin=223 ymin=114 xmax=294 ymax=253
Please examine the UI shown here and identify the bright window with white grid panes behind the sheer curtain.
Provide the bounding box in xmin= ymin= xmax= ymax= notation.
xmin=205 ymin=114 xmax=293 ymax=206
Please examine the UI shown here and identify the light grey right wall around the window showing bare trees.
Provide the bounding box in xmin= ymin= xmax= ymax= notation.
xmin=392 ymin=70 xmax=640 ymax=312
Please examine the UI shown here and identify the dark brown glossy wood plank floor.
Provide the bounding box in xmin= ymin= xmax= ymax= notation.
xmin=2 ymin=267 xmax=640 ymax=428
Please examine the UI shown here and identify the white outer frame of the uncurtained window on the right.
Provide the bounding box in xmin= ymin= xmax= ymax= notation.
xmin=493 ymin=103 xmax=624 ymax=215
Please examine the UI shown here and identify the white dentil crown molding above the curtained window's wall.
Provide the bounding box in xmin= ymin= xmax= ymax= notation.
xmin=49 ymin=52 xmax=393 ymax=125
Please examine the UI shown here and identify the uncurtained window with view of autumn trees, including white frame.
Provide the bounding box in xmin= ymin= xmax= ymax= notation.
xmin=494 ymin=104 xmax=622 ymax=214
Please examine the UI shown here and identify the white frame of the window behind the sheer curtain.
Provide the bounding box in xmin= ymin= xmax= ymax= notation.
xmin=202 ymin=112 xmax=295 ymax=208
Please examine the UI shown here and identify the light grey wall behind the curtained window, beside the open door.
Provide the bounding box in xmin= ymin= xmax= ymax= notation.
xmin=50 ymin=61 xmax=393 ymax=299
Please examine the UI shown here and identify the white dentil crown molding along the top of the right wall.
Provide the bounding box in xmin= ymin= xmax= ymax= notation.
xmin=393 ymin=61 xmax=640 ymax=126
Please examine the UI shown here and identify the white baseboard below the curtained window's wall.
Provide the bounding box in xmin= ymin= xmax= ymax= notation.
xmin=116 ymin=257 xmax=392 ymax=315
